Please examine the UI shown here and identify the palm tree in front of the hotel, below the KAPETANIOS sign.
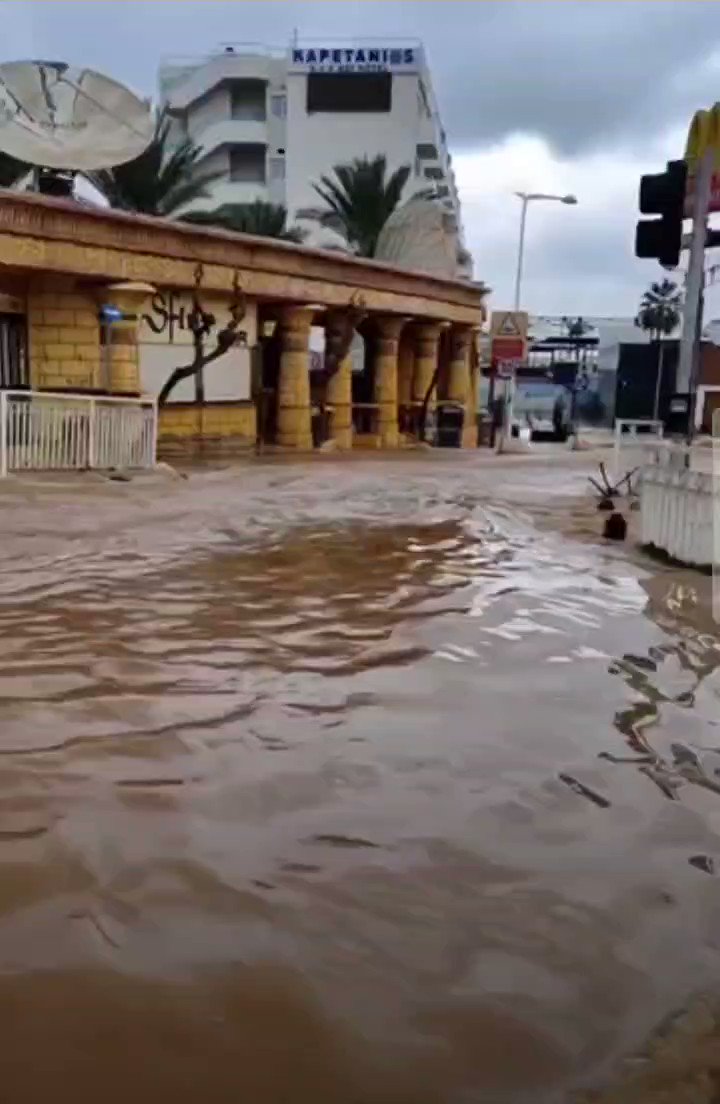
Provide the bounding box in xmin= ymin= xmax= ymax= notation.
xmin=305 ymin=153 xmax=424 ymax=257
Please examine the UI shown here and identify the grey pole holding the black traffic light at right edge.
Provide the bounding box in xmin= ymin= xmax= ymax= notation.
xmin=676 ymin=149 xmax=714 ymax=430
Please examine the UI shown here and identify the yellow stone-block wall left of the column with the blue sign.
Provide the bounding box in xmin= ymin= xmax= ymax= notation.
xmin=27 ymin=278 xmax=103 ymax=391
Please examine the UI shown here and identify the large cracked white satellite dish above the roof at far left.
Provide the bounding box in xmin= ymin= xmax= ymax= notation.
xmin=0 ymin=61 xmax=155 ymax=172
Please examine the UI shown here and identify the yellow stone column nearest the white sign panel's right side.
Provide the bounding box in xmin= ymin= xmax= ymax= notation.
xmin=277 ymin=307 xmax=316 ymax=449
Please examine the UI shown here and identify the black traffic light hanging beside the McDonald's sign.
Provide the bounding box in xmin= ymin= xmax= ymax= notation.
xmin=635 ymin=161 xmax=688 ymax=268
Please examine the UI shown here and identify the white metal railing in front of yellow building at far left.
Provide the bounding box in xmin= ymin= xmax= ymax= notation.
xmin=0 ymin=391 xmax=158 ymax=477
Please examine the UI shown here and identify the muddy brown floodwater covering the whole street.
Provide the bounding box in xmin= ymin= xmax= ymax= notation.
xmin=0 ymin=454 xmax=720 ymax=1104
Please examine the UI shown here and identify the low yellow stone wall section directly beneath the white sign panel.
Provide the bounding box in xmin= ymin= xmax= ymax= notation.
xmin=158 ymin=402 xmax=257 ymax=456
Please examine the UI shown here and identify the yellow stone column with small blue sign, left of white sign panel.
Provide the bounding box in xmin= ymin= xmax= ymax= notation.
xmin=97 ymin=282 xmax=157 ymax=395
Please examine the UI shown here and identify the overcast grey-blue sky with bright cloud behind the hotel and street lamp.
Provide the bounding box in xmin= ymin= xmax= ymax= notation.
xmin=0 ymin=0 xmax=720 ymax=315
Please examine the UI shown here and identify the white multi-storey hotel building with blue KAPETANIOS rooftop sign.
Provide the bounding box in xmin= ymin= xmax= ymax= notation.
xmin=159 ymin=41 xmax=462 ymax=257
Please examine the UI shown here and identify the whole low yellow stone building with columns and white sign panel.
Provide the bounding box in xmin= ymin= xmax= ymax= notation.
xmin=0 ymin=192 xmax=487 ymax=456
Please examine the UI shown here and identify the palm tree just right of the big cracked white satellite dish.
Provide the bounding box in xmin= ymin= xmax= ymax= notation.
xmin=86 ymin=107 xmax=222 ymax=215
